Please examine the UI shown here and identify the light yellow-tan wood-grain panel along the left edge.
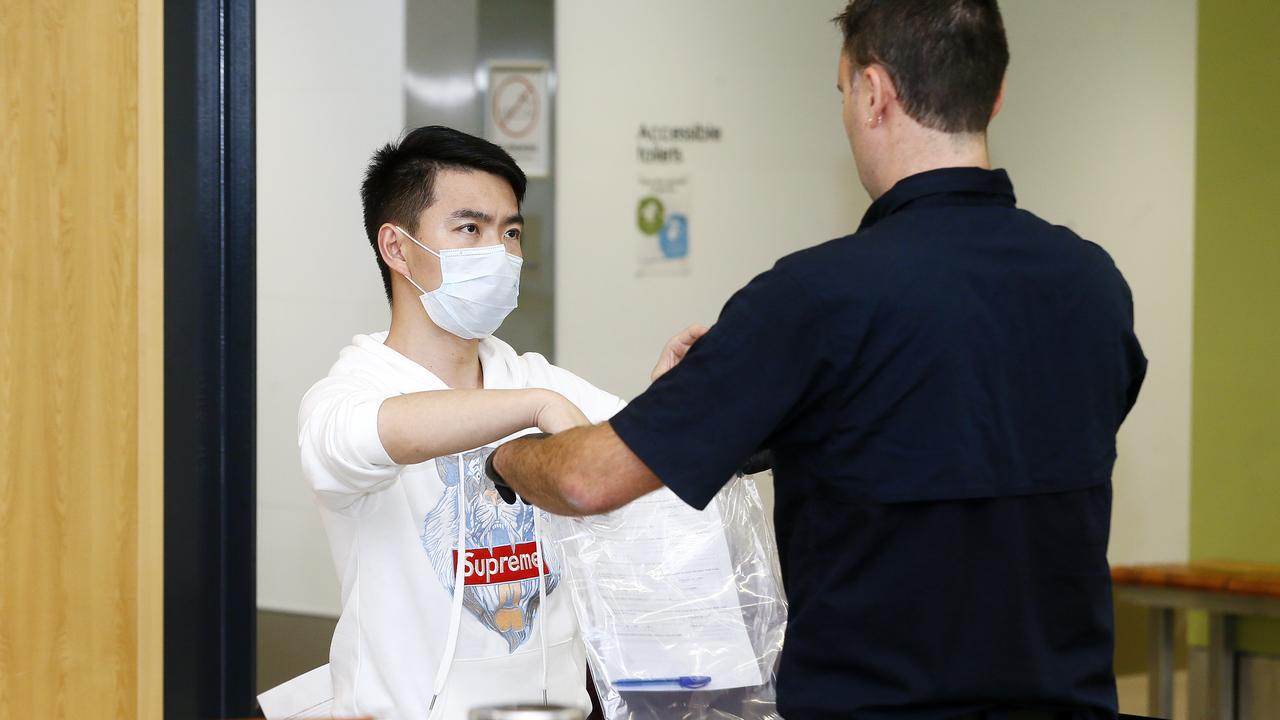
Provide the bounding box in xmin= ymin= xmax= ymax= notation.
xmin=0 ymin=0 xmax=163 ymax=717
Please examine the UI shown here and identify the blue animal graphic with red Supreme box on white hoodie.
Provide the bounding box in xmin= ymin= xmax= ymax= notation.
xmin=422 ymin=447 xmax=559 ymax=652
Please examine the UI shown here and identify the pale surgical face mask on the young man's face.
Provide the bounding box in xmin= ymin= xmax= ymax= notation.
xmin=394 ymin=225 xmax=524 ymax=340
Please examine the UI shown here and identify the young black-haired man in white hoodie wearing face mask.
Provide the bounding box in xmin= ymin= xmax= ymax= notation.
xmin=298 ymin=127 xmax=698 ymax=719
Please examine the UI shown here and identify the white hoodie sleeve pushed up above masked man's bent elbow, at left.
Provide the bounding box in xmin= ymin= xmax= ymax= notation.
xmin=298 ymin=377 xmax=401 ymax=510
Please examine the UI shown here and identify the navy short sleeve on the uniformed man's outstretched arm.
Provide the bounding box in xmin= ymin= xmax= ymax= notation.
xmin=611 ymin=268 xmax=824 ymax=510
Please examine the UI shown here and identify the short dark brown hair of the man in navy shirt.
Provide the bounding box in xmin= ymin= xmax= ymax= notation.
xmin=833 ymin=0 xmax=1009 ymax=133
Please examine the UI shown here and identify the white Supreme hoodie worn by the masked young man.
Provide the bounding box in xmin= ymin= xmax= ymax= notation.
xmin=298 ymin=333 xmax=622 ymax=720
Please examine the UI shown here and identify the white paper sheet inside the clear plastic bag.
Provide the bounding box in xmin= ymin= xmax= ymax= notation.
xmin=576 ymin=488 xmax=762 ymax=692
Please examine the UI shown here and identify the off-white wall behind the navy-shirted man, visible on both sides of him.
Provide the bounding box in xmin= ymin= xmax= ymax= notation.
xmin=556 ymin=0 xmax=1196 ymax=562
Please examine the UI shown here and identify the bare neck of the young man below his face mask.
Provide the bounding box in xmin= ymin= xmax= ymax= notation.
xmin=387 ymin=297 xmax=484 ymax=389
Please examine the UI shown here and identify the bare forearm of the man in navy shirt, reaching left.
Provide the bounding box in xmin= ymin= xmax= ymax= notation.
xmin=493 ymin=423 xmax=662 ymax=515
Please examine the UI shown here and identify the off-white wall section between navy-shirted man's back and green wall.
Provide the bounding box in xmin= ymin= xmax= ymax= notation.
xmin=991 ymin=0 xmax=1196 ymax=562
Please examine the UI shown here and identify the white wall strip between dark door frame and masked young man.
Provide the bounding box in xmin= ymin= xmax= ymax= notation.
xmin=257 ymin=0 xmax=404 ymax=615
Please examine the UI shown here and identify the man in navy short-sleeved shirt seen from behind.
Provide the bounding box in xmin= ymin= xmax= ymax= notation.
xmin=493 ymin=0 xmax=1146 ymax=720
